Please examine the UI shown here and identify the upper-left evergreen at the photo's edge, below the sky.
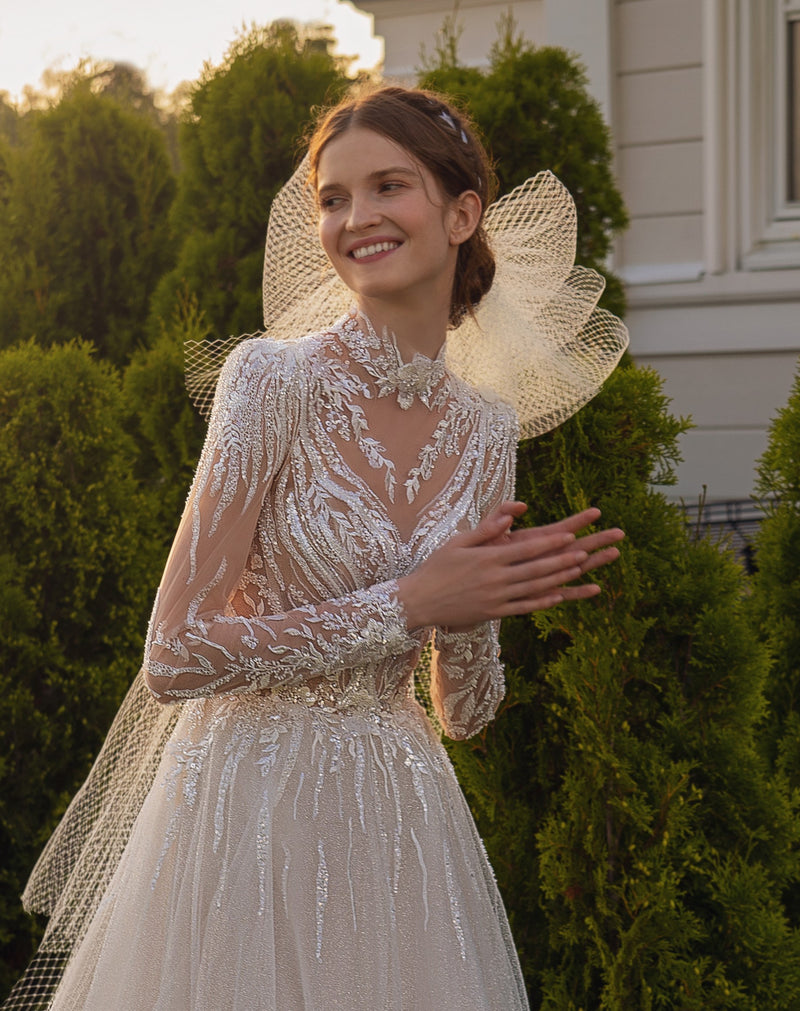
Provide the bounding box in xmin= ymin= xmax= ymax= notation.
xmin=0 ymin=80 xmax=175 ymax=363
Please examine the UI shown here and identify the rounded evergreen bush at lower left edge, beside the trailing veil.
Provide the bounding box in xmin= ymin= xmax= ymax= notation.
xmin=0 ymin=343 xmax=160 ymax=986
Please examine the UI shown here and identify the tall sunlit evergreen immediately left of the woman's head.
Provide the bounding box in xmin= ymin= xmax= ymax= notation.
xmin=153 ymin=22 xmax=348 ymax=336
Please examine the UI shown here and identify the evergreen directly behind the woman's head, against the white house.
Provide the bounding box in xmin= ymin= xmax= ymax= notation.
xmin=420 ymin=16 xmax=628 ymax=314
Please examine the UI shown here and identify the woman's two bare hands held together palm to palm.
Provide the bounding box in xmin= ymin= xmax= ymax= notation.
xmin=397 ymin=501 xmax=625 ymax=631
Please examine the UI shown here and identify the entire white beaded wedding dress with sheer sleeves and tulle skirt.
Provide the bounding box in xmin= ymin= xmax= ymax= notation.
xmin=16 ymin=313 xmax=528 ymax=1011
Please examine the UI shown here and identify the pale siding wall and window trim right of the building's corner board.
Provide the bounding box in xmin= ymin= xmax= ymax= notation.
xmin=613 ymin=0 xmax=800 ymax=500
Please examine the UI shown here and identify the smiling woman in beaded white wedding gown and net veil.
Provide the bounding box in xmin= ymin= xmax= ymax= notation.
xmin=9 ymin=88 xmax=624 ymax=1011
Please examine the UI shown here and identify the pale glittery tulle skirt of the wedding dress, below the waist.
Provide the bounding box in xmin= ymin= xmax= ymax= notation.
xmin=47 ymin=693 xmax=528 ymax=1011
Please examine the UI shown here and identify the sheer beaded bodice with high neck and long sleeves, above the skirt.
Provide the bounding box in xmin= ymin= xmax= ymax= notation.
xmin=146 ymin=313 xmax=516 ymax=736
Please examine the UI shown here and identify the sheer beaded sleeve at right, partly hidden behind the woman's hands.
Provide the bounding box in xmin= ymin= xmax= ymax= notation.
xmin=431 ymin=409 xmax=517 ymax=740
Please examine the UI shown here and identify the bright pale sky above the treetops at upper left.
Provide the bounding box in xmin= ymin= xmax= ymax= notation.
xmin=0 ymin=0 xmax=382 ymax=101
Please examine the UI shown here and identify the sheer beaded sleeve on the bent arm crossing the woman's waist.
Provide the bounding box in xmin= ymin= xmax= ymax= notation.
xmin=145 ymin=339 xmax=419 ymax=703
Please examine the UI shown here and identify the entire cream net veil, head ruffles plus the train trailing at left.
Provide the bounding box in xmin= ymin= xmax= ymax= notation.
xmin=4 ymin=162 xmax=628 ymax=1009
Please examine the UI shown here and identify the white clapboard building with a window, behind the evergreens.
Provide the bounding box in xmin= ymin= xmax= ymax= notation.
xmin=355 ymin=0 xmax=800 ymax=502
